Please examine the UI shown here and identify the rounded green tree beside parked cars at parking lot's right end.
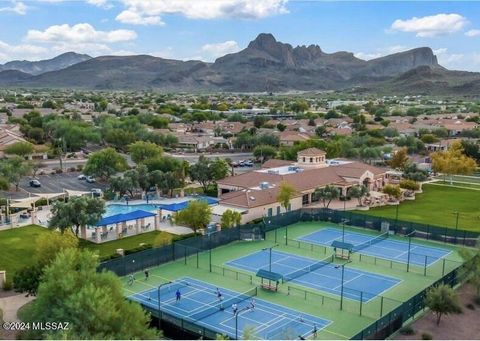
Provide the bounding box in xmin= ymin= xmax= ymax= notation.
xmin=83 ymin=148 xmax=128 ymax=180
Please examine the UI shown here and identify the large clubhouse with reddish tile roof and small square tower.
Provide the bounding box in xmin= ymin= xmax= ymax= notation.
xmin=217 ymin=148 xmax=386 ymax=223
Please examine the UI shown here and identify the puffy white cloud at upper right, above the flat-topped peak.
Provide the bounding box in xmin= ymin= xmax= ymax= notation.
xmin=391 ymin=13 xmax=468 ymax=38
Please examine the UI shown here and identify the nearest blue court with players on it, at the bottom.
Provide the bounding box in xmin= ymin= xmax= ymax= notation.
xmin=129 ymin=277 xmax=331 ymax=339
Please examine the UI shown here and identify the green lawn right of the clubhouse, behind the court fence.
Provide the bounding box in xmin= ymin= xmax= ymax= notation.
xmin=358 ymin=184 xmax=480 ymax=232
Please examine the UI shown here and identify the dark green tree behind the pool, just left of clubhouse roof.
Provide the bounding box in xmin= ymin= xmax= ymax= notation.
xmin=190 ymin=155 xmax=230 ymax=192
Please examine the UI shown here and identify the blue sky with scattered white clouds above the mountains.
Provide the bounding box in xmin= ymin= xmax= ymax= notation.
xmin=0 ymin=0 xmax=480 ymax=71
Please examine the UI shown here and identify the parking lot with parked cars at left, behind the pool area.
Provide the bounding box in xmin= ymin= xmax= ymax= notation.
xmin=3 ymin=172 xmax=105 ymax=198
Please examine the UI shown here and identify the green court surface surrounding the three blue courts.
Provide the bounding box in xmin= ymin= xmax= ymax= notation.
xmin=122 ymin=222 xmax=462 ymax=339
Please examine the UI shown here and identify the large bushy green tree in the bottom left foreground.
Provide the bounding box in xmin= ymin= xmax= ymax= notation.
xmin=25 ymin=249 xmax=158 ymax=339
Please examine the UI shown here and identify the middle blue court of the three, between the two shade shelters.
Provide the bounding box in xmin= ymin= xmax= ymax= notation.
xmin=226 ymin=250 xmax=401 ymax=302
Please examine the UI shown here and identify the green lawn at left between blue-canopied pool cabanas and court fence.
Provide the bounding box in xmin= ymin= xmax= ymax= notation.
xmin=0 ymin=225 xmax=182 ymax=279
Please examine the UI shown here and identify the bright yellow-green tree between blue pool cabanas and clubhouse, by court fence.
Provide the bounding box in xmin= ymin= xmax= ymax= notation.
xmin=173 ymin=200 xmax=212 ymax=233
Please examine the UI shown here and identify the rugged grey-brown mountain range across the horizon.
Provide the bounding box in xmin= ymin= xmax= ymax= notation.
xmin=0 ymin=33 xmax=480 ymax=95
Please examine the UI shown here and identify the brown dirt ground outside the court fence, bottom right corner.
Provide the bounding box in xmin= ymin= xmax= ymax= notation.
xmin=395 ymin=285 xmax=480 ymax=340
